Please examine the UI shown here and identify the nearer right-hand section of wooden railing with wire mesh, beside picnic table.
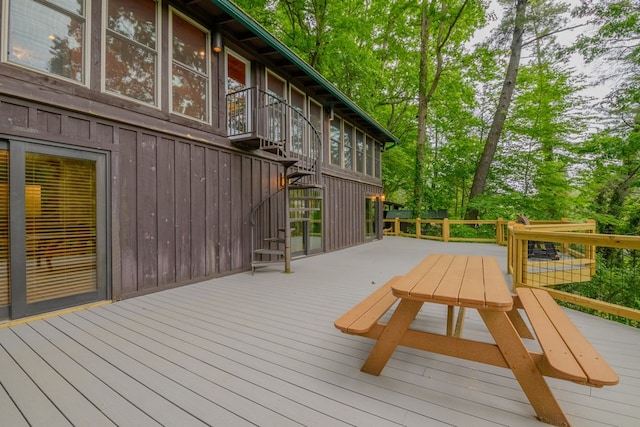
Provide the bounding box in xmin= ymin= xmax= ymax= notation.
xmin=507 ymin=221 xmax=640 ymax=326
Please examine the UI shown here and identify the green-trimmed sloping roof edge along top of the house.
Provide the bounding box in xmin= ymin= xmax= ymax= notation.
xmin=210 ymin=0 xmax=400 ymax=145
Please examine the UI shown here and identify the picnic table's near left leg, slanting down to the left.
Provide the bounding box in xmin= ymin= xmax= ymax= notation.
xmin=360 ymin=299 xmax=422 ymax=375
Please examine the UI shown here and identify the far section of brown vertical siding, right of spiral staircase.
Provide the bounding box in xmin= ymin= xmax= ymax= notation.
xmin=324 ymin=175 xmax=382 ymax=251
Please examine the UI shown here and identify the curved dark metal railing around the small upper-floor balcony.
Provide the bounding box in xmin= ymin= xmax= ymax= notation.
xmin=227 ymin=87 xmax=322 ymax=182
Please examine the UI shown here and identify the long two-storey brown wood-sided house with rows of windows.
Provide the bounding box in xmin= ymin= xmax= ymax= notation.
xmin=0 ymin=0 xmax=397 ymax=319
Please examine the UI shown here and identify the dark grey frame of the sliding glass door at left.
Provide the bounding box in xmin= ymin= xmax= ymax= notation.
xmin=0 ymin=138 xmax=111 ymax=319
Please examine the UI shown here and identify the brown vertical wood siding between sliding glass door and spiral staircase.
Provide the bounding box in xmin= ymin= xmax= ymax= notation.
xmin=0 ymin=95 xmax=281 ymax=298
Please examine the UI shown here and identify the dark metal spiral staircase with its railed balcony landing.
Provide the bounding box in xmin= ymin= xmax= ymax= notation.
xmin=226 ymin=87 xmax=322 ymax=274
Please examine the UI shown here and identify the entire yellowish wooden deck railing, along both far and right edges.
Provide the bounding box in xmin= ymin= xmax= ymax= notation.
xmin=384 ymin=218 xmax=640 ymax=327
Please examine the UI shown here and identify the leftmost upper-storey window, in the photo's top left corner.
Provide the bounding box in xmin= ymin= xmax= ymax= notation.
xmin=2 ymin=0 xmax=88 ymax=83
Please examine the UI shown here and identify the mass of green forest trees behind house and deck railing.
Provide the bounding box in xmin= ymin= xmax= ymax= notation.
xmin=236 ymin=0 xmax=640 ymax=234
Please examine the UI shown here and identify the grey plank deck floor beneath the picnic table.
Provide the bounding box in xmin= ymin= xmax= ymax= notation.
xmin=0 ymin=237 xmax=640 ymax=427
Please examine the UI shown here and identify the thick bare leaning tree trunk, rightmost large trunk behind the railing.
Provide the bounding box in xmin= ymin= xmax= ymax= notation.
xmin=466 ymin=0 xmax=529 ymax=219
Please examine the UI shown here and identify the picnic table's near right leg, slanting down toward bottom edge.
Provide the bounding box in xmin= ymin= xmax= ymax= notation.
xmin=478 ymin=310 xmax=570 ymax=426
